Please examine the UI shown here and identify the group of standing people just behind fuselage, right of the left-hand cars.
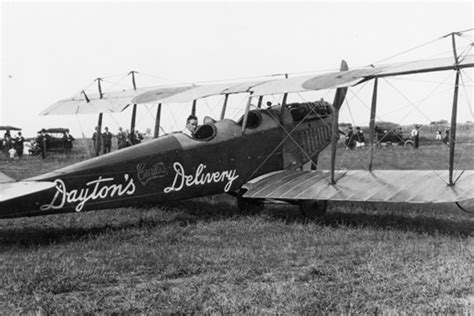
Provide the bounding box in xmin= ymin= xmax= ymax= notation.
xmin=92 ymin=127 xmax=143 ymax=154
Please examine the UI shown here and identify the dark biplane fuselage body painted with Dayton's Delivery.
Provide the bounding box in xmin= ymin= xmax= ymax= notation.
xmin=0 ymin=103 xmax=332 ymax=217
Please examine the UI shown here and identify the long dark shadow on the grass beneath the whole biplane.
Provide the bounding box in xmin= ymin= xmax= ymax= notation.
xmin=0 ymin=197 xmax=474 ymax=251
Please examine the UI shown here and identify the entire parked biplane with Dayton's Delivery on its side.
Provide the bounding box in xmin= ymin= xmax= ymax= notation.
xmin=0 ymin=33 xmax=474 ymax=218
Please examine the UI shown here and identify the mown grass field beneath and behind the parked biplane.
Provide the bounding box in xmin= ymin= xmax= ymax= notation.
xmin=0 ymin=138 xmax=474 ymax=314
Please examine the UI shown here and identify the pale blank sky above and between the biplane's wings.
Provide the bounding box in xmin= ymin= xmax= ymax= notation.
xmin=0 ymin=0 xmax=474 ymax=137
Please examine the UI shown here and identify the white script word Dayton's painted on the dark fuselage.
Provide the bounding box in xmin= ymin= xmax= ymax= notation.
xmin=40 ymin=174 xmax=136 ymax=212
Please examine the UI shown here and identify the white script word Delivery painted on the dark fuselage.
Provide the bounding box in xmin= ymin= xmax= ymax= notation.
xmin=163 ymin=162 xmax=239 ymax=193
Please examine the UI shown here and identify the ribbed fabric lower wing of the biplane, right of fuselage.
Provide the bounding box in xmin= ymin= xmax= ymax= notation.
xmin=243 ymin=170 xmax=474 ymax=203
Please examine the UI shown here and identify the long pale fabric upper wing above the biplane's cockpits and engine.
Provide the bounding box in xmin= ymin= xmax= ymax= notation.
xmin=40 ymin=55 xmax=474 ymax=115
